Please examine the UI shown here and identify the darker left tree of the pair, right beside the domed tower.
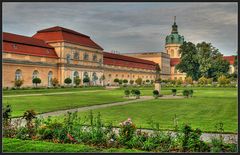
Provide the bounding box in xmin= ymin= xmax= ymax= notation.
xmin=176 ymin=42 xmax=199 ymax=80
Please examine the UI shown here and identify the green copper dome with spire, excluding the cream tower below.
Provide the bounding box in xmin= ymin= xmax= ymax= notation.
xmin=166 ymin=17 xmax=184 ymax=44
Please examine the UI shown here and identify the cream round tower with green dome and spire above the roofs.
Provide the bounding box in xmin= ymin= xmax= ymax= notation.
xmin=165 ymin=16 xmax=184 ymax=58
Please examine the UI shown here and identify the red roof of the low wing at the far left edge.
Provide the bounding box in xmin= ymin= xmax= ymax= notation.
xmin=2 ymin=32 xmax=58 ymax=58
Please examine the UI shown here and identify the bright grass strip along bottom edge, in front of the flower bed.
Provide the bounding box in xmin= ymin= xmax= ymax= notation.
xmin=3 ymin=138 xmax=143 ymax=153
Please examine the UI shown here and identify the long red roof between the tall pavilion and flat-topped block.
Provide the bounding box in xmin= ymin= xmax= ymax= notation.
xmin=103 ymin=52 xmax=157 ymax=70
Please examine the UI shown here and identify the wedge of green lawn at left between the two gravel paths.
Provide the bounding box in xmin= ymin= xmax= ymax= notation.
xmin=3 ymin=90 xmax=131 ymax=116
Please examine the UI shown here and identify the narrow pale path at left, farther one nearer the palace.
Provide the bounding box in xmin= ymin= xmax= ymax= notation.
xmin=3 ymin=90 xmax=108 ymax=97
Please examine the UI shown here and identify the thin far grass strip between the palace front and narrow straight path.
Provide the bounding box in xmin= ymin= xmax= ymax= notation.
xmin=3 ymin=87 xmax=104 ymax=96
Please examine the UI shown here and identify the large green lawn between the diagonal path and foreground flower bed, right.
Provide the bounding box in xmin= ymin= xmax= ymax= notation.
xmin=67 ymin=88 xmax=237 ymax=133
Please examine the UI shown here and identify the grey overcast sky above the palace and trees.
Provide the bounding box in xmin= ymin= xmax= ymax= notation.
xmin=3 ymin=2 xmax=238 ymax=55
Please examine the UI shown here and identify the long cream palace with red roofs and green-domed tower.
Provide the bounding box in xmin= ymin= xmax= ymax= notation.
xmin=2 ymin=18 xmax=234 ymax=87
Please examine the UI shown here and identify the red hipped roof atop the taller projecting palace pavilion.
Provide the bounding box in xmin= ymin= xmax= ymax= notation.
xmin=33 ymin=26 xmax=103 ymax=50
